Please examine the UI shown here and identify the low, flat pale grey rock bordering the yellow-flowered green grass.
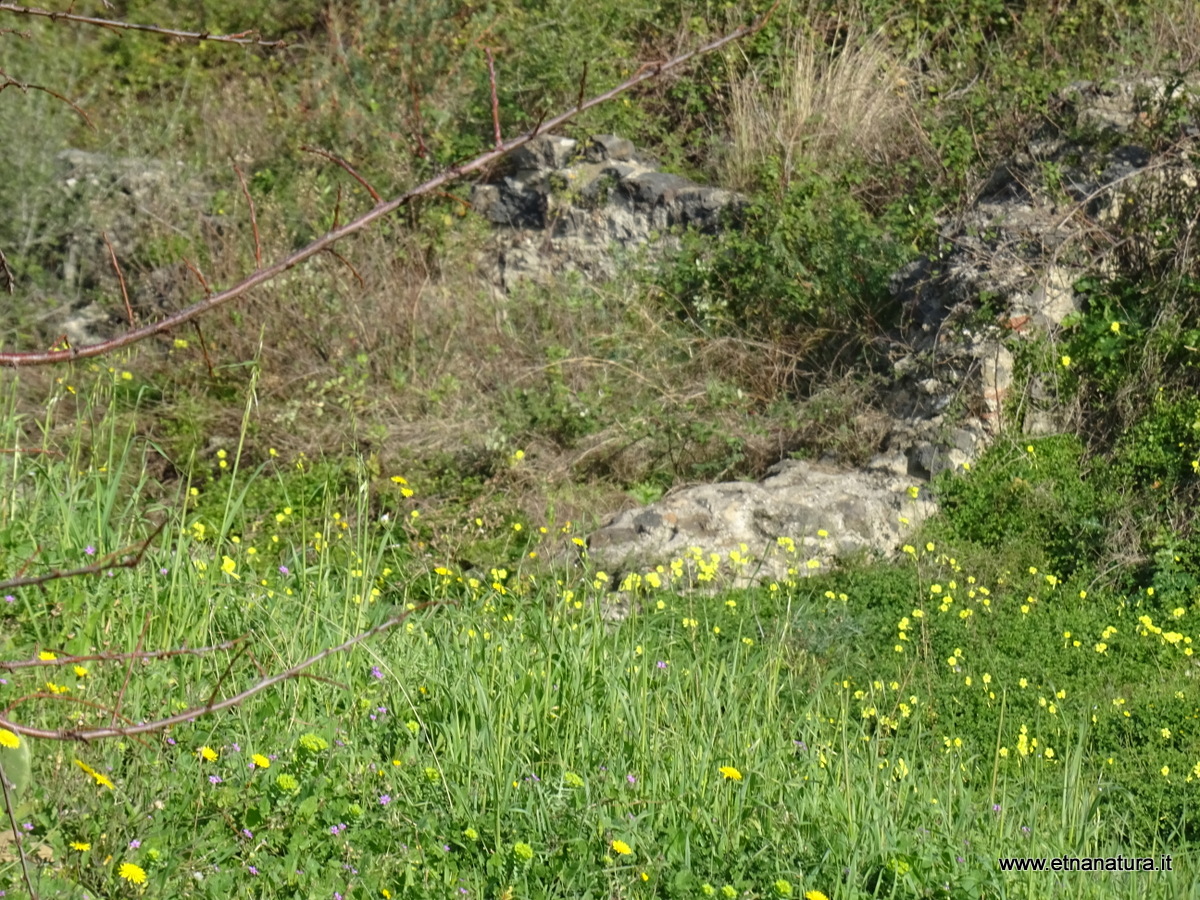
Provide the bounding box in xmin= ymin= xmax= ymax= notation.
xmin=588 ymin=460 xmax=935 ymax=584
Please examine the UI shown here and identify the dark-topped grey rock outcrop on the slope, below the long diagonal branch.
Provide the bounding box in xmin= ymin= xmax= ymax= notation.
xmin=472 ymin=134 xmax=744 ymax=292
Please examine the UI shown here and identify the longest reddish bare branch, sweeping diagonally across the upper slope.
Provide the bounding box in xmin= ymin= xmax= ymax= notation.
xmin=0 ymin=8 xmax=779 ymax=367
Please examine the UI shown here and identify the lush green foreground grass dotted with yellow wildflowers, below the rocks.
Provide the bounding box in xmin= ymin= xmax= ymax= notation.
xmin=0 ymin=371 xmax=1200 ymax=899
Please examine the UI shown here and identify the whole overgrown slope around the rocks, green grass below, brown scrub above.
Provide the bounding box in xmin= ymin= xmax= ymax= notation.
xmin=0 ymin=2 xmax=1200 ymax=898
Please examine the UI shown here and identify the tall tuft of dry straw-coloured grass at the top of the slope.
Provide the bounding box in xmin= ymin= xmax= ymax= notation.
xmin=721 ymin=15 xmax=924 ymax=188
